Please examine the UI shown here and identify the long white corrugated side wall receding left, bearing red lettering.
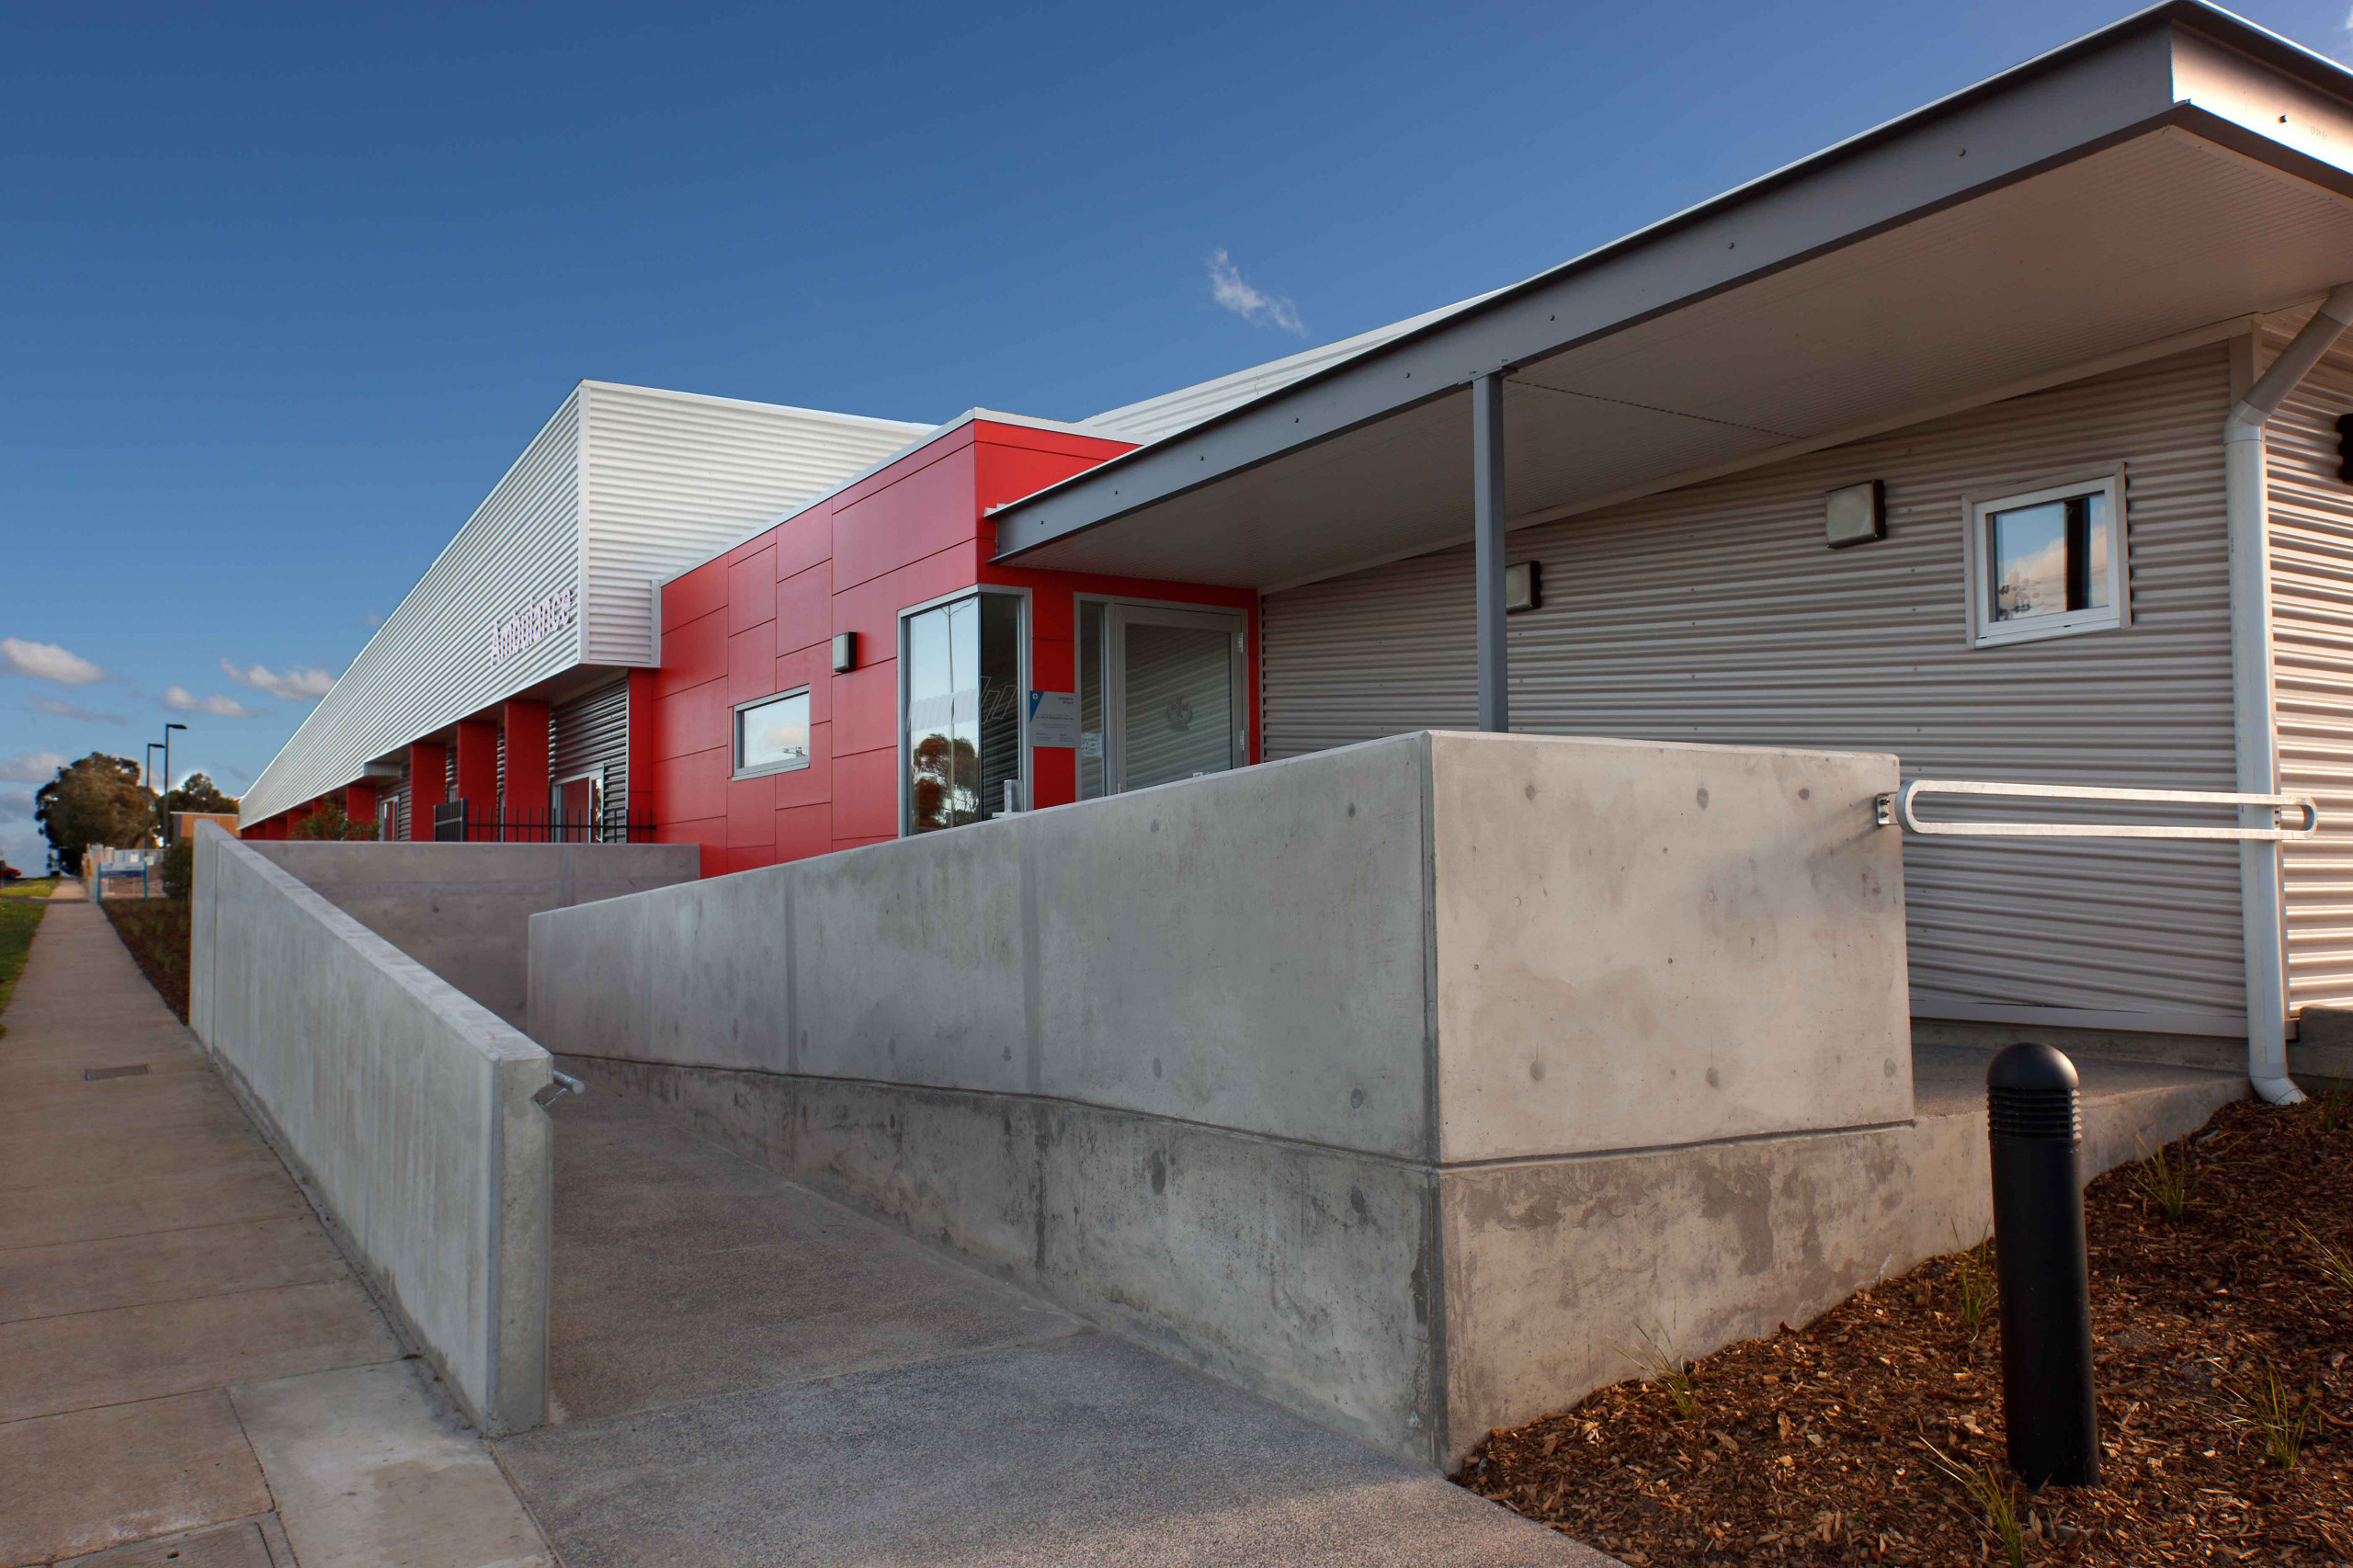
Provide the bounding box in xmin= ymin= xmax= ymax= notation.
xmin=238 ymin=391 xmax=579 ymax=824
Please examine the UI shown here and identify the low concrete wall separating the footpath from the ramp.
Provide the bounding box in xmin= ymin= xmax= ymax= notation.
xmin=188 ymin=824 xmax=553 ymax=1434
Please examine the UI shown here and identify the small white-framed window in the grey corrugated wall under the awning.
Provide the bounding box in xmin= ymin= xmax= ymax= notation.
xmin=1970 ymin=473 xmax=2131 ymax=647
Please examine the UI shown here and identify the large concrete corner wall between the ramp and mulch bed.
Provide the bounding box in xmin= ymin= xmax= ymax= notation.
xmin=529 ymin=734 xmax=1944 ymax=1462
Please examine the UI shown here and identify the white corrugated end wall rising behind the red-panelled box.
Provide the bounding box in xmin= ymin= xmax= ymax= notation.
xmin=581 ymin=381 xmax=929 ymax=666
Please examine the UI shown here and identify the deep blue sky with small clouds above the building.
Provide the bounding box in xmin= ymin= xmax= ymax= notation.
xmin=0 ymin=0 xmax=2353 ymax=867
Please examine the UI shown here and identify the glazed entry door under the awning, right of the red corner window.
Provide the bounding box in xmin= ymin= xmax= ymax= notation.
xmin=1077 ymin=600 xmax=1249 ymax=798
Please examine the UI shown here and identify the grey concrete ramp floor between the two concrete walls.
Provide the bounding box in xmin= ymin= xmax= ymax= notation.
xmin=496 ymin=1085 xmax=1609 ymax=1568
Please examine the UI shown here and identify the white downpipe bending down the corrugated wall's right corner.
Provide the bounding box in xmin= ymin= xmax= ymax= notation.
xmin=2222 ymin=282 xmax=2353 ymax=1104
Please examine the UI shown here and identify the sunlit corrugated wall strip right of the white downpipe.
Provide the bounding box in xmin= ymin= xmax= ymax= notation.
xmin=2264 ymin=336 xmax=2353 ymax=1007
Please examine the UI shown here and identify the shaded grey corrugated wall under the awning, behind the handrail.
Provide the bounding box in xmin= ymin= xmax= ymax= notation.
xmin=1264 ymin=348 xmax=2245 ymax=1034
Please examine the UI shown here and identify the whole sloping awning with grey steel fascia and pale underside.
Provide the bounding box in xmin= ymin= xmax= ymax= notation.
xmin=993 ymin=3 xmax=2353 ymax=591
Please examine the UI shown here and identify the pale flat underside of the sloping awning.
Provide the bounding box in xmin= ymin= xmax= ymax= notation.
xmin=1018 ymin=127 xmax=2353 ymax=588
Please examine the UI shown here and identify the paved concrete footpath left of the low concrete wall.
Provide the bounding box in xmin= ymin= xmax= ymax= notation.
xmin=0 ymin=890 xmax=553 ymax=1568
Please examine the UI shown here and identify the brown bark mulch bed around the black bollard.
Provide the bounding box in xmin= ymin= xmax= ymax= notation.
xmin=1454 ymin=1099 xmax=2353 ymax=1568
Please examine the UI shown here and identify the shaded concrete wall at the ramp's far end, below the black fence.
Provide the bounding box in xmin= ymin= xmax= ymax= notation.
xmin=247 ymin=838 xmax=701 ymax=1028
